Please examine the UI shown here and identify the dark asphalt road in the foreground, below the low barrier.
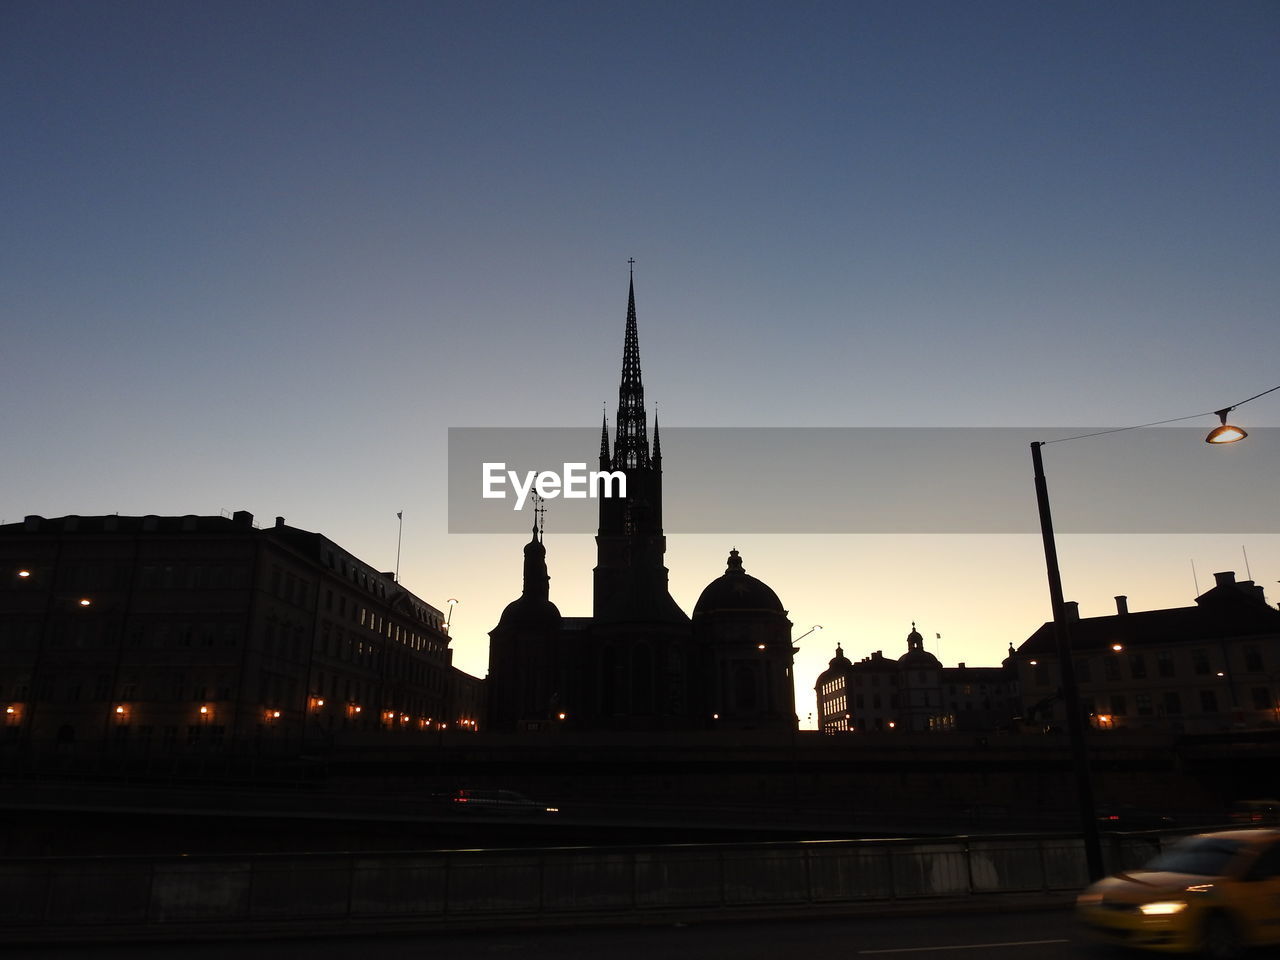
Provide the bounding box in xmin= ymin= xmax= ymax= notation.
xmin=15 ymin=910 xmax=1096 ymax=960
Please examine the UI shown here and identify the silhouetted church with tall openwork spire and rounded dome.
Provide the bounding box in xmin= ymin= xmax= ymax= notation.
xmin=488 ymin=276 xmax=796 ymax=731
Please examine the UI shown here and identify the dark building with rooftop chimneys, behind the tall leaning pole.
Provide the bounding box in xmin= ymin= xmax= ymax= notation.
xmin=1011 ymin=571 xmax=1280 ymax=732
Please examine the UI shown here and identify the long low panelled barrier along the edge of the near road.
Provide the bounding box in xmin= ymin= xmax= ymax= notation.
xmin=0 ymin=835 xmax=1177 ymax=937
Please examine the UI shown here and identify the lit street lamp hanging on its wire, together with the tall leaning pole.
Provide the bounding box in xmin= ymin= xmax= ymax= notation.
xmin=1032 ymin=385 xmax=1280 ymax=881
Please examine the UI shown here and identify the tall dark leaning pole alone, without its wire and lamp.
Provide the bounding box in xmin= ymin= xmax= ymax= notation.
xmin=1032 ymin=442 xmax=1105 ymax=881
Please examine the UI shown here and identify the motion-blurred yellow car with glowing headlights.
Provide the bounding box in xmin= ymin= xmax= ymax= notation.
xmin=1075 ymin=829 xmax=1280 ymax=960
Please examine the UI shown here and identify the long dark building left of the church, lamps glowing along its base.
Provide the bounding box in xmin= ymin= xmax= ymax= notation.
xmin=0 ymin=511 xmax=481 ymax=754
